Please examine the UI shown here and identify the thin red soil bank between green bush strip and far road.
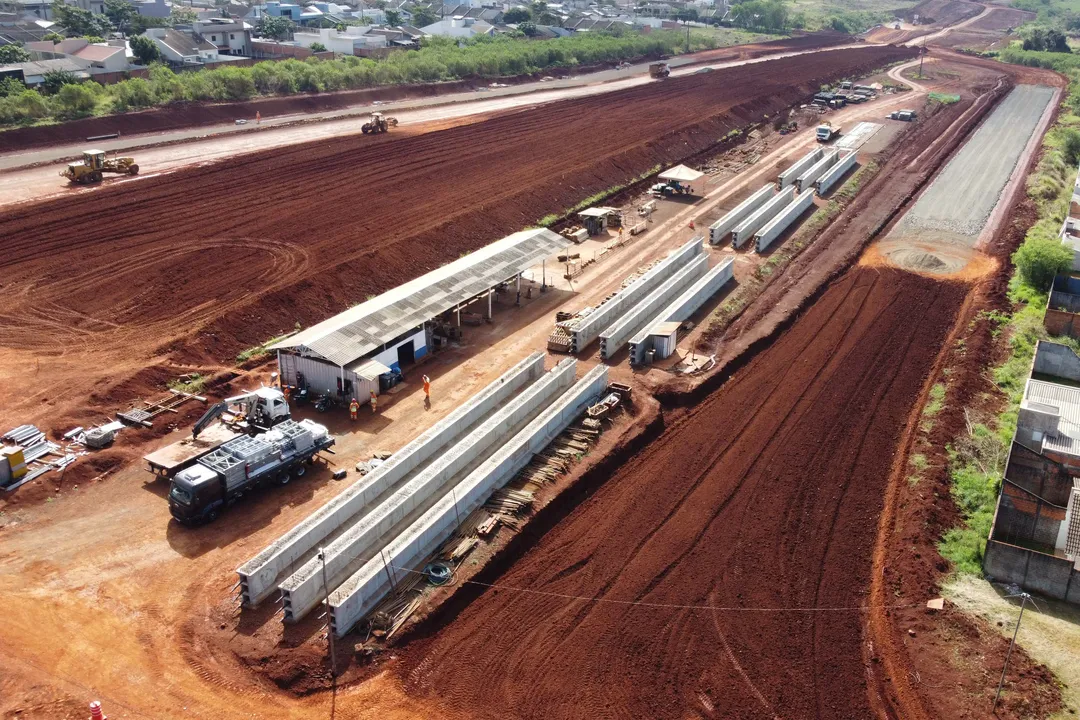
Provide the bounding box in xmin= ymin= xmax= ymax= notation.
xmin=0 ymin=32 xmax=851 ymax=153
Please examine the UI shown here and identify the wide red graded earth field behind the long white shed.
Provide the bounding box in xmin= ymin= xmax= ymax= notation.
xmin=0 ymin=47 xmax=914 ymax=425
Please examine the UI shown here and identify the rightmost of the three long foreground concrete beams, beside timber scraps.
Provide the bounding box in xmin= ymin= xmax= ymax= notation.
xmin=330 ymin=365 xmax=608 ymax=637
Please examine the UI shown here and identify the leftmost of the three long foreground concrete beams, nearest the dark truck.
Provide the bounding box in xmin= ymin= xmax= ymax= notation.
xmin=237 ymin=352 xmax=544 ymax=608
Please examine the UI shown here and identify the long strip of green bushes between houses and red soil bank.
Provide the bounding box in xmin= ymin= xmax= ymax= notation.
xmin=0 ymin=29 xmax=725 ymax=125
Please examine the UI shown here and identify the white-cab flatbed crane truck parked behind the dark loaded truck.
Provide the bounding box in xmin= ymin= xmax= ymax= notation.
xmin=144 ymin=388 xmax=292 ymax=479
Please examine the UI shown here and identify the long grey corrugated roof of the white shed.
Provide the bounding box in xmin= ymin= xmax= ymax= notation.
xmin=271 ymin=229 xmax=567 ymax=366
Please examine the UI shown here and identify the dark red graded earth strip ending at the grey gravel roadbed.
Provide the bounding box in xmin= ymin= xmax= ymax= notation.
xmin=405 ymin=268 xmax=968 ymax=718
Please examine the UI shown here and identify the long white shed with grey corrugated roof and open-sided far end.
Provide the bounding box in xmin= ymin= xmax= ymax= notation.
xmin=271 ymin=229 xmax=566 ymax=403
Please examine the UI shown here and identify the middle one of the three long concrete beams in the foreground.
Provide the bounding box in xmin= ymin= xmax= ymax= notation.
xmin=281 ymin=358 xmax=577 ymax=623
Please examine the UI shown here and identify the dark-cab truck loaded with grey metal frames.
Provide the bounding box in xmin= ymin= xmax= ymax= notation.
xmin=168 ymin=419 xmax=334 ymax=525
